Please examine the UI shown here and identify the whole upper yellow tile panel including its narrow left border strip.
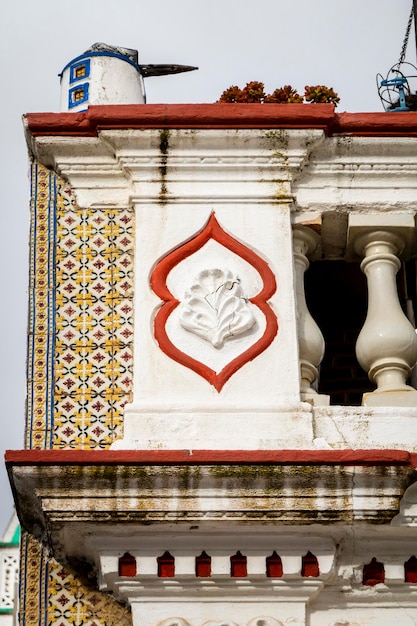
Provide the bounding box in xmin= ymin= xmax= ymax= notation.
xmin=26 ymin=163 xmax=134 ymax=448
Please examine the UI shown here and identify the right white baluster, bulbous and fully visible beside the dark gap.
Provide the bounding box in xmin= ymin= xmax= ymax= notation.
xmin=354 ymin=229 xmax=417 ymax=406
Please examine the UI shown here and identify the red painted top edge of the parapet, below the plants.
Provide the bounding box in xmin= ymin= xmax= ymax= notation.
xmin=25 ymin=103 xmax=417 ymax=137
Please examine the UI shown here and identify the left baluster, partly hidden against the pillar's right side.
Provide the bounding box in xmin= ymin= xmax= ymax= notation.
xmin=293 ymin=225 xmax=329 ymax=405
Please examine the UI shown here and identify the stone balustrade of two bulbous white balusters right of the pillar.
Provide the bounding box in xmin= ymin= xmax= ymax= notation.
xmin=293 ymin=214 xmax=417 ymax=407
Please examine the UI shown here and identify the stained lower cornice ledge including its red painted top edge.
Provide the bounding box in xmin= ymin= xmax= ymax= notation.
xmin=6 ymin=450 xmax=417 ymax=557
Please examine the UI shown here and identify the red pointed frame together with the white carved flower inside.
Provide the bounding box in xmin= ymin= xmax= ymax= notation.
xmin=150 ymin=213 xmax=278 ymax=392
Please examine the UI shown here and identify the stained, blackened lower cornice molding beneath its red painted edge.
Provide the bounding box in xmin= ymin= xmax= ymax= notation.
xmin=9 ymin=451 xmax=417 ymax=559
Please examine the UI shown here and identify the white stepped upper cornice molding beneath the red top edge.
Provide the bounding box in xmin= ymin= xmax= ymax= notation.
xmin=28 ymin=126 xmax=417 ymax=258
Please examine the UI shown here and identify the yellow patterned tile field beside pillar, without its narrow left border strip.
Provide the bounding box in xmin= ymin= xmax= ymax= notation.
xmin=54 ymin=190 xmax=133 ymax=448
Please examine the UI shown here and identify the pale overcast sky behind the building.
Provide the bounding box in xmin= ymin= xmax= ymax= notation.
xmin=0 ymin=0 xmax=416 ymax=536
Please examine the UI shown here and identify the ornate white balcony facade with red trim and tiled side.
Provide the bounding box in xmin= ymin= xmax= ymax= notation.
xmin=7 ymin=104 xmax=417 ymax=626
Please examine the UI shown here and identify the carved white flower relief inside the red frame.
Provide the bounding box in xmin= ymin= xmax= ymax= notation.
xmin=180 ymin=269 xmax=256 ymax=348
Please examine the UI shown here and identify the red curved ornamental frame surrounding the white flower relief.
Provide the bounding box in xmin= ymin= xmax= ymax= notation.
xmin=150 ymin=212 xmax=278 ymax=392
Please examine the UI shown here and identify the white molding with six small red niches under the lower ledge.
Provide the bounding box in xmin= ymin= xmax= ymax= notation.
xmin=96 ymin=524 xmax=336 ymax=626
